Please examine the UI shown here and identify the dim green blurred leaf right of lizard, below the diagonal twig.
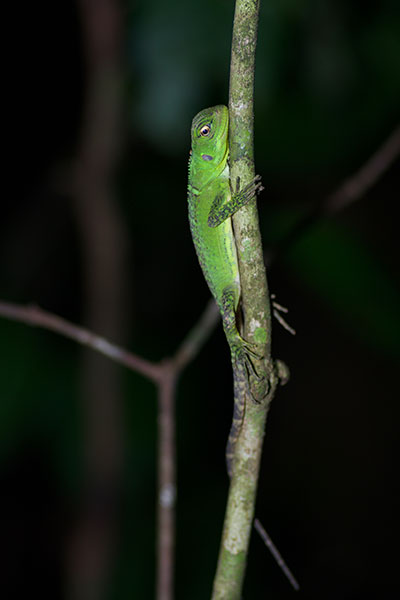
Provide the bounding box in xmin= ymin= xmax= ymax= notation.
xmin=264 ymin=210 xmax=400 ymax=358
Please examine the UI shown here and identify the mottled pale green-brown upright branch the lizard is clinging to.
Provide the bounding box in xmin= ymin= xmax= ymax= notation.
xmin=212 ymin=0 xmax=277 ymax=600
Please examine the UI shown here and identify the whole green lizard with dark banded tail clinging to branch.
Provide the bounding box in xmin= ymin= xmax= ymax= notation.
xmin=188 ymin=105 xmax=262 ymax=476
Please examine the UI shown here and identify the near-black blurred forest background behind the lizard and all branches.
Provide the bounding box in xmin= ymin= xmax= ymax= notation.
xmin=0 ymin=0 xmax=400 ymax=600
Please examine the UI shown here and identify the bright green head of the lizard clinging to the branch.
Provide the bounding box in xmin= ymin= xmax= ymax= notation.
xmin=192 ymin=104 xmax=229 ymax=165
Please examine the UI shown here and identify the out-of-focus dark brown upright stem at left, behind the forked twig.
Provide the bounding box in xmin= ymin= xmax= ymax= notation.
xmin=67 ymin=0 xmax=128 ymax=600
